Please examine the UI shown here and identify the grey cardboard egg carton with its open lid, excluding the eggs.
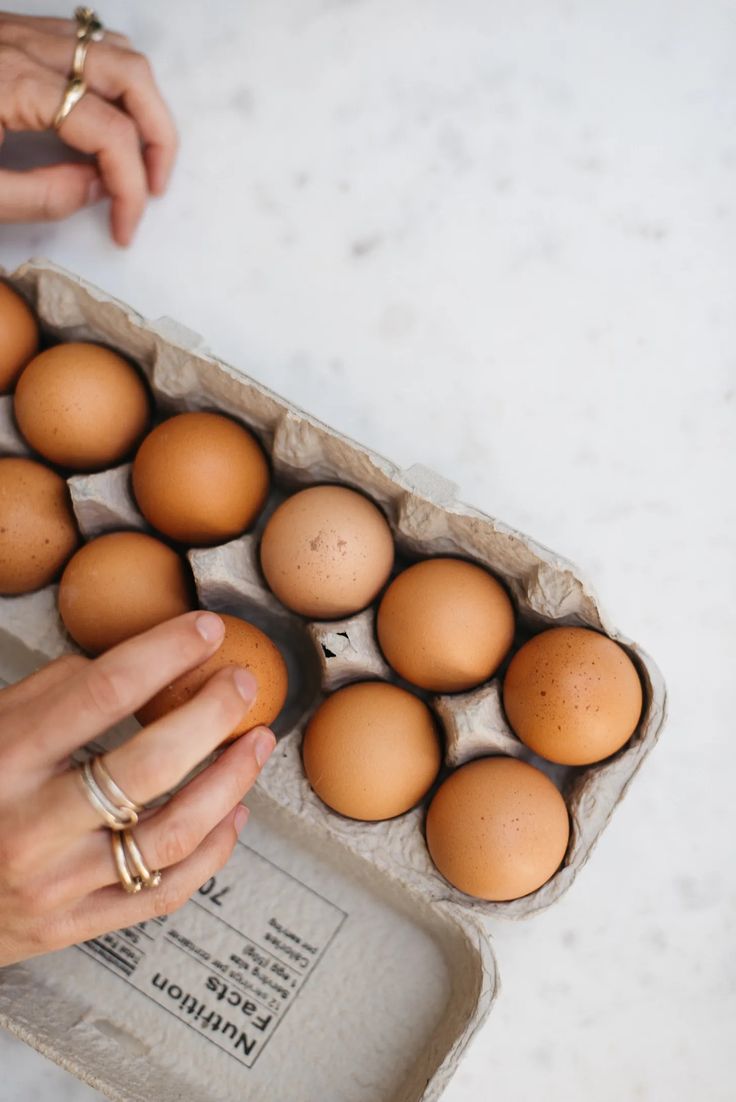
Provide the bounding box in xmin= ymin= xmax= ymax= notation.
xmin=0 ymin=261 xmax=665 ymax=1102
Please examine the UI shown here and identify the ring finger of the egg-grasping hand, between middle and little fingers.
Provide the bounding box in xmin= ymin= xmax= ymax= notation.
xmin=37 ymin=727 xmax=275 ymax=909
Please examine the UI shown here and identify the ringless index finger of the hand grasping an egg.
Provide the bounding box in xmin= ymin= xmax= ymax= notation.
xmin=13 ymin=612 xmax=225 ymax=766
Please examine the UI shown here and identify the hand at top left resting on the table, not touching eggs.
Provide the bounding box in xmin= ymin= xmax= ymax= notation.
xmin=0 ymin=12 xmax=177 ymax=245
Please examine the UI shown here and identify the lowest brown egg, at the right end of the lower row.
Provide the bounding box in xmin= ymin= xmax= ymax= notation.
xmin=426 ymin=757 xmax=570 ymax=901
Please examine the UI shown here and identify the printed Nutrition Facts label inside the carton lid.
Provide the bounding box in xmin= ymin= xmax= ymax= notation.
xmin=78 ymin=843 xmax=347 ymax=1068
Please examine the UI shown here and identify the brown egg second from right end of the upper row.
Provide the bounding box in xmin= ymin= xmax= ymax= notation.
xmin=376 ymin=559 xmax=513 ymax=692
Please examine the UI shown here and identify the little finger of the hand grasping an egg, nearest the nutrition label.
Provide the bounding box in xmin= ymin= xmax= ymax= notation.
xmin=55 ymin=804 xmax=241 ymax=951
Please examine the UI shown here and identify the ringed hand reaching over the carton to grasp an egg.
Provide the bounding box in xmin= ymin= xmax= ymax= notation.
xmin=0 ymin=612 xmax=275 ymax=965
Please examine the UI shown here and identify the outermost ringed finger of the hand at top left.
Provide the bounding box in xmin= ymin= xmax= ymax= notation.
xmin=4 ymin=26 xmax=178 ymax=195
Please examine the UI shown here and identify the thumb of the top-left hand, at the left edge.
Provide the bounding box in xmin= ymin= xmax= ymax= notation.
xmin=0 ymin=164 xmax=105 ymax=223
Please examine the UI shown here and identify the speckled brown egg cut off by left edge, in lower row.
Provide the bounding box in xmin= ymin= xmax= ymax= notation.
xmin=0 ymin=458 xmax=79 ymax=594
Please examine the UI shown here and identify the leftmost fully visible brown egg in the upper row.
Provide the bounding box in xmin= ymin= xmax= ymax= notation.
xmin=14 ymin=341 xmax=150 ymax=471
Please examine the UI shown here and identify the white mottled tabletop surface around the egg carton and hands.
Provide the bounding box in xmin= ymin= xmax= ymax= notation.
xmin=0 ymin=0 xmax=736 ymax=1102
